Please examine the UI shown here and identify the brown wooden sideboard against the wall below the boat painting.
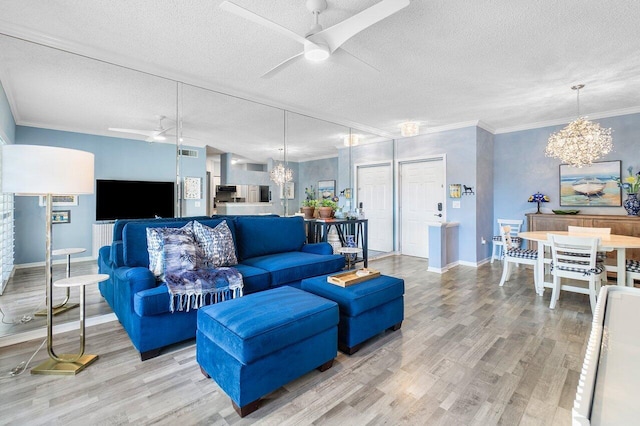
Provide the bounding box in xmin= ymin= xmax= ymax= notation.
xmin=526 ymin=213 xmax=640 ymax=260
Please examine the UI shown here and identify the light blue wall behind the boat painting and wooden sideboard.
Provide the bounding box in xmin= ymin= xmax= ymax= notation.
xmin=493 ymin=114 xmax=640 ymax=243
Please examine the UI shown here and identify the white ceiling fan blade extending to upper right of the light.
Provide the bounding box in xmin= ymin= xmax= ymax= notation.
xmin=309 ymin=0 xmax=409 ymax=53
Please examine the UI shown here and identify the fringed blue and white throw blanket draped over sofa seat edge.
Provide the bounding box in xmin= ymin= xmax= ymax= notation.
xmin=165 ymin=267 xmax=243 ymax=312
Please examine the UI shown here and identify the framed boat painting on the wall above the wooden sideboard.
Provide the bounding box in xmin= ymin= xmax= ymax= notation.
xmin=560 ymin=160 xmax=622 ymax=207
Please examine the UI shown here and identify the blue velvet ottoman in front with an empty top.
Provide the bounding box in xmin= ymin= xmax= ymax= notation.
xmin=196 ymin=286 xmax=339 ymax=417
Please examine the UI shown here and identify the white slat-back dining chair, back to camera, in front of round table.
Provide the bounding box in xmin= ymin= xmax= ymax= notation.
xmin=549 ymin=234 xmax=604 ymax=312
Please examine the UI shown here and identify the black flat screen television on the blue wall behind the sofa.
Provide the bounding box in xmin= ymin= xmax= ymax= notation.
xmin=96 ymin=179 xmax=175 ymax=220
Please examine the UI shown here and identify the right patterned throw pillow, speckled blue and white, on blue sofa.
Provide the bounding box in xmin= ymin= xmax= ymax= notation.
xmin=193 ymin=220 xmax=238 ymax=268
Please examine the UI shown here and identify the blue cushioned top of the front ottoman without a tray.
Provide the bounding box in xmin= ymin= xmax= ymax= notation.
xmin=198 ymin=287 xmax=339 ymax=362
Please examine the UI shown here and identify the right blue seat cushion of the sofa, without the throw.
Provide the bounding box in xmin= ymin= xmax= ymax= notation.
xmin=242 ymin=251 xmax=345 ymax=287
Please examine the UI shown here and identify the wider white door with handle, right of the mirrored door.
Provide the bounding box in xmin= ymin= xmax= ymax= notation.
xmin=399 ymin=158 xmax=444 ymax=258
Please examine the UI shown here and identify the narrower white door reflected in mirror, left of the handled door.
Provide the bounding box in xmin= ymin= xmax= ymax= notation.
xmin=356 ymin=164 xmax=393 ymax=252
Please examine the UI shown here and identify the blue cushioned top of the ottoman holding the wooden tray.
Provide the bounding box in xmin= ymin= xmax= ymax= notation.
xmin=300 ymin=275 xmax=404 ymax=317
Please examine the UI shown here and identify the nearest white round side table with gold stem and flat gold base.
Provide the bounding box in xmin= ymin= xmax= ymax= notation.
xmin=31 ymin=274 xmax=109 ymax=375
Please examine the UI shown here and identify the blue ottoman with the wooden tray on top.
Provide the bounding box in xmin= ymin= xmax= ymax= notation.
xmin=300 ymin=275 xmax=404 ymax=355
